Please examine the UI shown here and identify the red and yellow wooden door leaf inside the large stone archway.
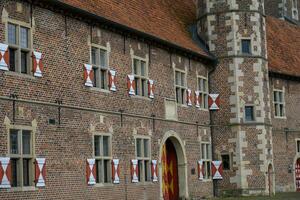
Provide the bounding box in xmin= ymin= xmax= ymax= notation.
xmin=162 ymin=140 xmax=179 ymax=200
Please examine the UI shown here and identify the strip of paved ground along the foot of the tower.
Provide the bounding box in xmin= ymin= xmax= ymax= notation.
xmin=212 ymin=192 xmax=300 ymax=200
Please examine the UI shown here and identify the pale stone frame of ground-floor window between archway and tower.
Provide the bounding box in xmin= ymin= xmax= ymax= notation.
xmin=200 ymin=141 xmax=212 ymax=181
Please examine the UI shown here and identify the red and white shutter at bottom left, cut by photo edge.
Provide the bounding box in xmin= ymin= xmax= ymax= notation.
xmin=0 ymin=157 xmax=11 ymax=188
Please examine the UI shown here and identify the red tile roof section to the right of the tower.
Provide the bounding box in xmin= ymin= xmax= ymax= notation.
xmin=267 ymin=17 xmax=300 ymax=76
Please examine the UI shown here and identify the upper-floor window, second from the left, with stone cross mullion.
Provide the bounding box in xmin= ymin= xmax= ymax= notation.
xmin=91 ymin=45 xmax=108 ymax=90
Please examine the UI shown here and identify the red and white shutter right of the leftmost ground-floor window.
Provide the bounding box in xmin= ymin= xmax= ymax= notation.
xmin=35 ymin=158 xmax=46 ymax=187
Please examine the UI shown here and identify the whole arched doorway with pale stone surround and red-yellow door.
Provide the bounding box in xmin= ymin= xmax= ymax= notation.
xmin=159 ymin=131 xmax=189 ymax=200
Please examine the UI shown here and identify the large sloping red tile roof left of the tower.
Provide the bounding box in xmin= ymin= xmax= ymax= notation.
xmin=60 ymin=0 xmax=208 ymax=56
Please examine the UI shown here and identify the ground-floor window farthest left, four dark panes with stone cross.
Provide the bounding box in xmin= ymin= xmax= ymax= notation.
xmin=9 ymin=129 xmax=34 ymax=187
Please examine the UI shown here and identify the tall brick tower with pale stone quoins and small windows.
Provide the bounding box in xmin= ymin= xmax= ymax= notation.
xmin=197 ymin=0 xmax=274 ymax=195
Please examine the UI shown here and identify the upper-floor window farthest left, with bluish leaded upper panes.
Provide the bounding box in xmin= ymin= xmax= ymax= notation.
xmin=7 ymin=23 xmax=32 ymax=74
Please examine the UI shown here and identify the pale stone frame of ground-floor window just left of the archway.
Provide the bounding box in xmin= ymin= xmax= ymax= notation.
xmin=134 ymin=135 xmax=152 ymax=183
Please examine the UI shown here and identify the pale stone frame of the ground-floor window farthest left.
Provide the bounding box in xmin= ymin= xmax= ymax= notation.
xmin=7 ymin=125 xmax=36 ymax=191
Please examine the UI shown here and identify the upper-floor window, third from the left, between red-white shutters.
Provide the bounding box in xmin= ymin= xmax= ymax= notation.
xmin=133 ymin=58 xmax=148 ymax=97
